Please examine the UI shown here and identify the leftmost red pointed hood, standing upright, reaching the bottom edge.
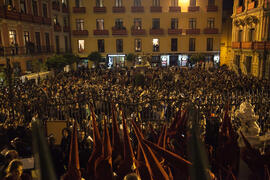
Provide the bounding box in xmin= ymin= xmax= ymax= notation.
xmin=64 ymin=121 xmax=81 ymax=180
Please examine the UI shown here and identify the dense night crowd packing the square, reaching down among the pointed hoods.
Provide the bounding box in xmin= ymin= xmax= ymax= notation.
xmin=0 ymin=66 xmax=270 ymax=179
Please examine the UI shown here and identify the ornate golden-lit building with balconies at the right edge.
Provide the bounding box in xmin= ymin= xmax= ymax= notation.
xmin=231 ymin=0 xmax=270 ymax=79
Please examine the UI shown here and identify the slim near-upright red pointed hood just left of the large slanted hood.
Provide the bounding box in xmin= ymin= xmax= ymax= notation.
xmin=122 ymin=113 xmax=135 ymax=164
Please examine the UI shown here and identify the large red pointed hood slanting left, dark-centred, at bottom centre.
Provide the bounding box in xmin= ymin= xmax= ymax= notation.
xmin=132 ymin=121 xmax=169 ymax=180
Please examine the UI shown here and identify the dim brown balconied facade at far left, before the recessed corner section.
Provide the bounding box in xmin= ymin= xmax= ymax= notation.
xmin=0 ymin=0 xmax=54 ymax=75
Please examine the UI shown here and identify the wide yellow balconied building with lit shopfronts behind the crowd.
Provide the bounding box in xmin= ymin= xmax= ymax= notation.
xmin=69 ymin=0 xmax=222 ymax=66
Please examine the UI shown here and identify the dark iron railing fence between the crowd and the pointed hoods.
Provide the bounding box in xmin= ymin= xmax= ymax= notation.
xmin=23 ymin=90 xmax=270 ymax=131
